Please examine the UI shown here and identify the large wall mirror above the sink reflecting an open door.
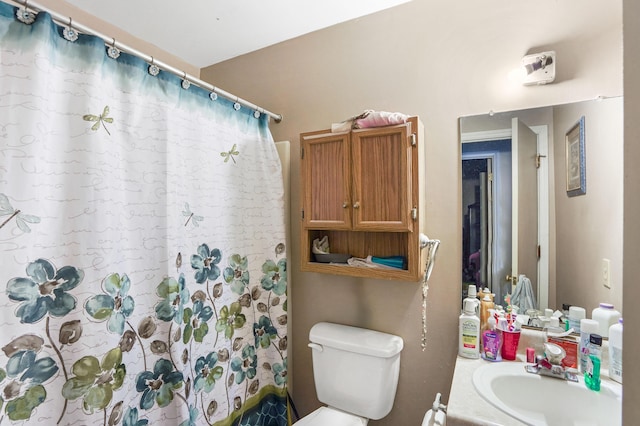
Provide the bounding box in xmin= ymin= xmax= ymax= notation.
xmin=460 ymin=97 xmax=623 ymax=322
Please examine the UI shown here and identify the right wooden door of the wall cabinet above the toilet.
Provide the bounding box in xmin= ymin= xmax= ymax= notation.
xmin=351 ymin=123 xmax=417 ymax=231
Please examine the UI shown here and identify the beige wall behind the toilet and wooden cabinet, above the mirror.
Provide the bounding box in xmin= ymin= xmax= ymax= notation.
xmin=201 ymin=0 xmax=626 ymax=425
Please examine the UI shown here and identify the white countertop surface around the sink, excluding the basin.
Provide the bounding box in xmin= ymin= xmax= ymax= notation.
xmin=447 ymin=329 xmax=609 ymax=426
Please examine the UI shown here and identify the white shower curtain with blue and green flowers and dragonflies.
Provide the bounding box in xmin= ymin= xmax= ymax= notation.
xmin=0 ymin=3 xmax=288 ymax=426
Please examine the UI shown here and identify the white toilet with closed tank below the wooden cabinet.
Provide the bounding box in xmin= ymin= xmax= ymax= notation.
xmin=294 ymin=322 xmax=403 ymax=426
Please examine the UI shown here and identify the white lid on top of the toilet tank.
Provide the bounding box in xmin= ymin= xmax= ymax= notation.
xmin=309 ymin=322 xmax=404 ymax=358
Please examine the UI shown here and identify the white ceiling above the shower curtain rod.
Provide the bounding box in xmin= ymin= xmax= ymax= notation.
xmin=66 ymin=0 xmax=410 ymax=68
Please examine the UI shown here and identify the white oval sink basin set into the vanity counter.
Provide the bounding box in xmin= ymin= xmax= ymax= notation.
xmin=473 ymin=361 xmax=622 ymax=426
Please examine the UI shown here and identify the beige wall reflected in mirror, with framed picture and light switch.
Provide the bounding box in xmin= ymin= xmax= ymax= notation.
xmin=553 ymin=98 xmax=624 ymax=316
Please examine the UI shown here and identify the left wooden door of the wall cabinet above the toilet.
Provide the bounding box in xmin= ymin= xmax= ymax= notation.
xmin=301 ymin=132 xmax=351 ymax=229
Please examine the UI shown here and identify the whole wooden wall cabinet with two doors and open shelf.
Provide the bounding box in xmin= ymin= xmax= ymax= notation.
xmin=300 ymin=117 xmax=425 ymax=281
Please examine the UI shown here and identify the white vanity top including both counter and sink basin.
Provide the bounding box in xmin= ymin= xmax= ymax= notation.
xmin=447 ymin=329 xmax=622 ymax=426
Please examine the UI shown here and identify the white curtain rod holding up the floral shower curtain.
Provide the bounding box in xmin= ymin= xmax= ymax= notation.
xmin=10 ymin=0 xmax=282 ymax=123
